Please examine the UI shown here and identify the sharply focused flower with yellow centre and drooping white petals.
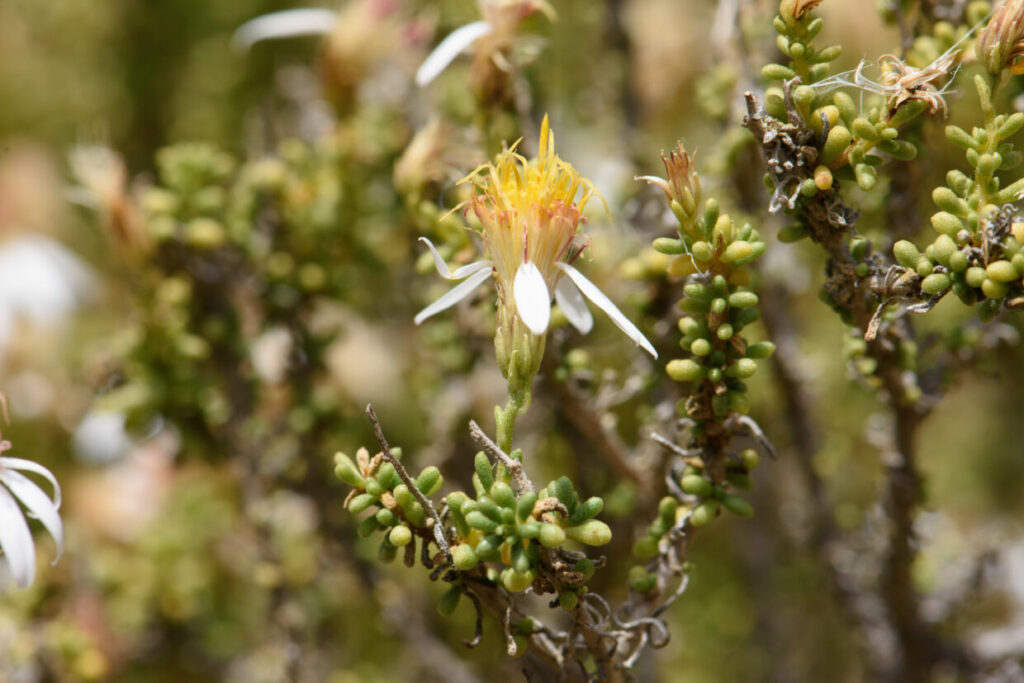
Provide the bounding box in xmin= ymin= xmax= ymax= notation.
xmin=415 ymin=117 xmax=657 ymax=371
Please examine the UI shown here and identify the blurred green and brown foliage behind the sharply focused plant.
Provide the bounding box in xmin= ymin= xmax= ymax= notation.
xmin=0 ymin=0 xmax=1024 ymax=683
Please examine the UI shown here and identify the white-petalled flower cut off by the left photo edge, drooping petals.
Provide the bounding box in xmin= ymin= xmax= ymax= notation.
xmin=0 ymin=439 xmax=63 ymax=588
